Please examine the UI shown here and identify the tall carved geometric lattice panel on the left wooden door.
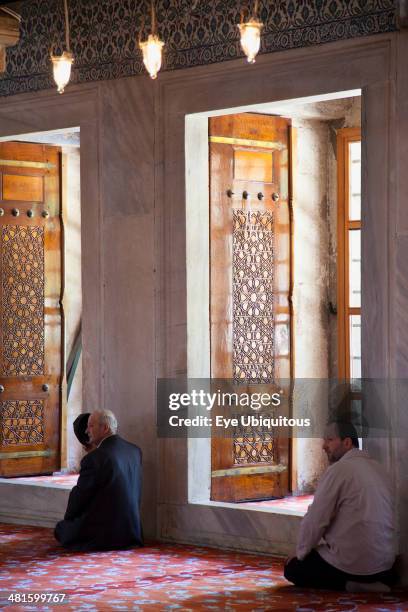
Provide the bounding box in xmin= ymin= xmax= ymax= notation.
xmin=1 ymin=225 xmax=44 ymax=376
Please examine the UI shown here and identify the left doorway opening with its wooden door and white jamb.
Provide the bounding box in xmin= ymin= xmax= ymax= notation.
xmin=0 ymin=128 xmax=82 ymax=477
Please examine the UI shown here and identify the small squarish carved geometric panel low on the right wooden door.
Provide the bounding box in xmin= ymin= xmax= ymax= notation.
xmin=233 ymin=413 xmax=277 ymax=465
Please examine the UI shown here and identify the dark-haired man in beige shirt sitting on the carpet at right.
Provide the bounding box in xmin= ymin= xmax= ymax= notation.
xmin=284 ymin=422 xmax=395 ymax=591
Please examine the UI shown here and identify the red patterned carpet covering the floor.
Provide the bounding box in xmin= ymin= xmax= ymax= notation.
xmin=0 ymin=525 xmax=408 ymax=612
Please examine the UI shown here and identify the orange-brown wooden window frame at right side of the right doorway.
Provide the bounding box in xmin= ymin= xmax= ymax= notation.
xmin=337 ymin=128 xmax=361 ymax=380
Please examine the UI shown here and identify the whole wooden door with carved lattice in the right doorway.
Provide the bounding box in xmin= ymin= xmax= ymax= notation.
xmin=209 ymin=113 xmax=291 ymax=501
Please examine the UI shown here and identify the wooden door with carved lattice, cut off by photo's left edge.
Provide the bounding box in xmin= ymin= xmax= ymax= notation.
xmin=0 ymin=143 xmax=62 ymax=476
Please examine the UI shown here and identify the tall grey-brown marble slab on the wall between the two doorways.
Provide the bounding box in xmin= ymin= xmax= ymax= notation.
xmin=99 ymin=78 xmax=157 ymax=536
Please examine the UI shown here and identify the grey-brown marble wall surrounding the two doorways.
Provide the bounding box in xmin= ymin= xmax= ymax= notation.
xmin=0 ymin=28 xmax=408 ymax=582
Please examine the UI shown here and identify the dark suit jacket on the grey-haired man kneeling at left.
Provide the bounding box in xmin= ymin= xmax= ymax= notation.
xmin=55 ymin=435 xmax=143 ymax=550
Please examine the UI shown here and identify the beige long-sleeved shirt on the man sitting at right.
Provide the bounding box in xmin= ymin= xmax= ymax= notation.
xmin=296 ymin=448 xmax=395 ymax=575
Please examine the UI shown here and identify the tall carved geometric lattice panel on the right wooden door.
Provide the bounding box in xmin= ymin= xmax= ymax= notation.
xmin=232 ymin=209 xmax=274 ymax=383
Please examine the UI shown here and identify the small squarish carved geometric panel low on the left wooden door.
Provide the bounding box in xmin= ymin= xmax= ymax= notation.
xmin=0 ymin=400 xmax=44 ymax=446
